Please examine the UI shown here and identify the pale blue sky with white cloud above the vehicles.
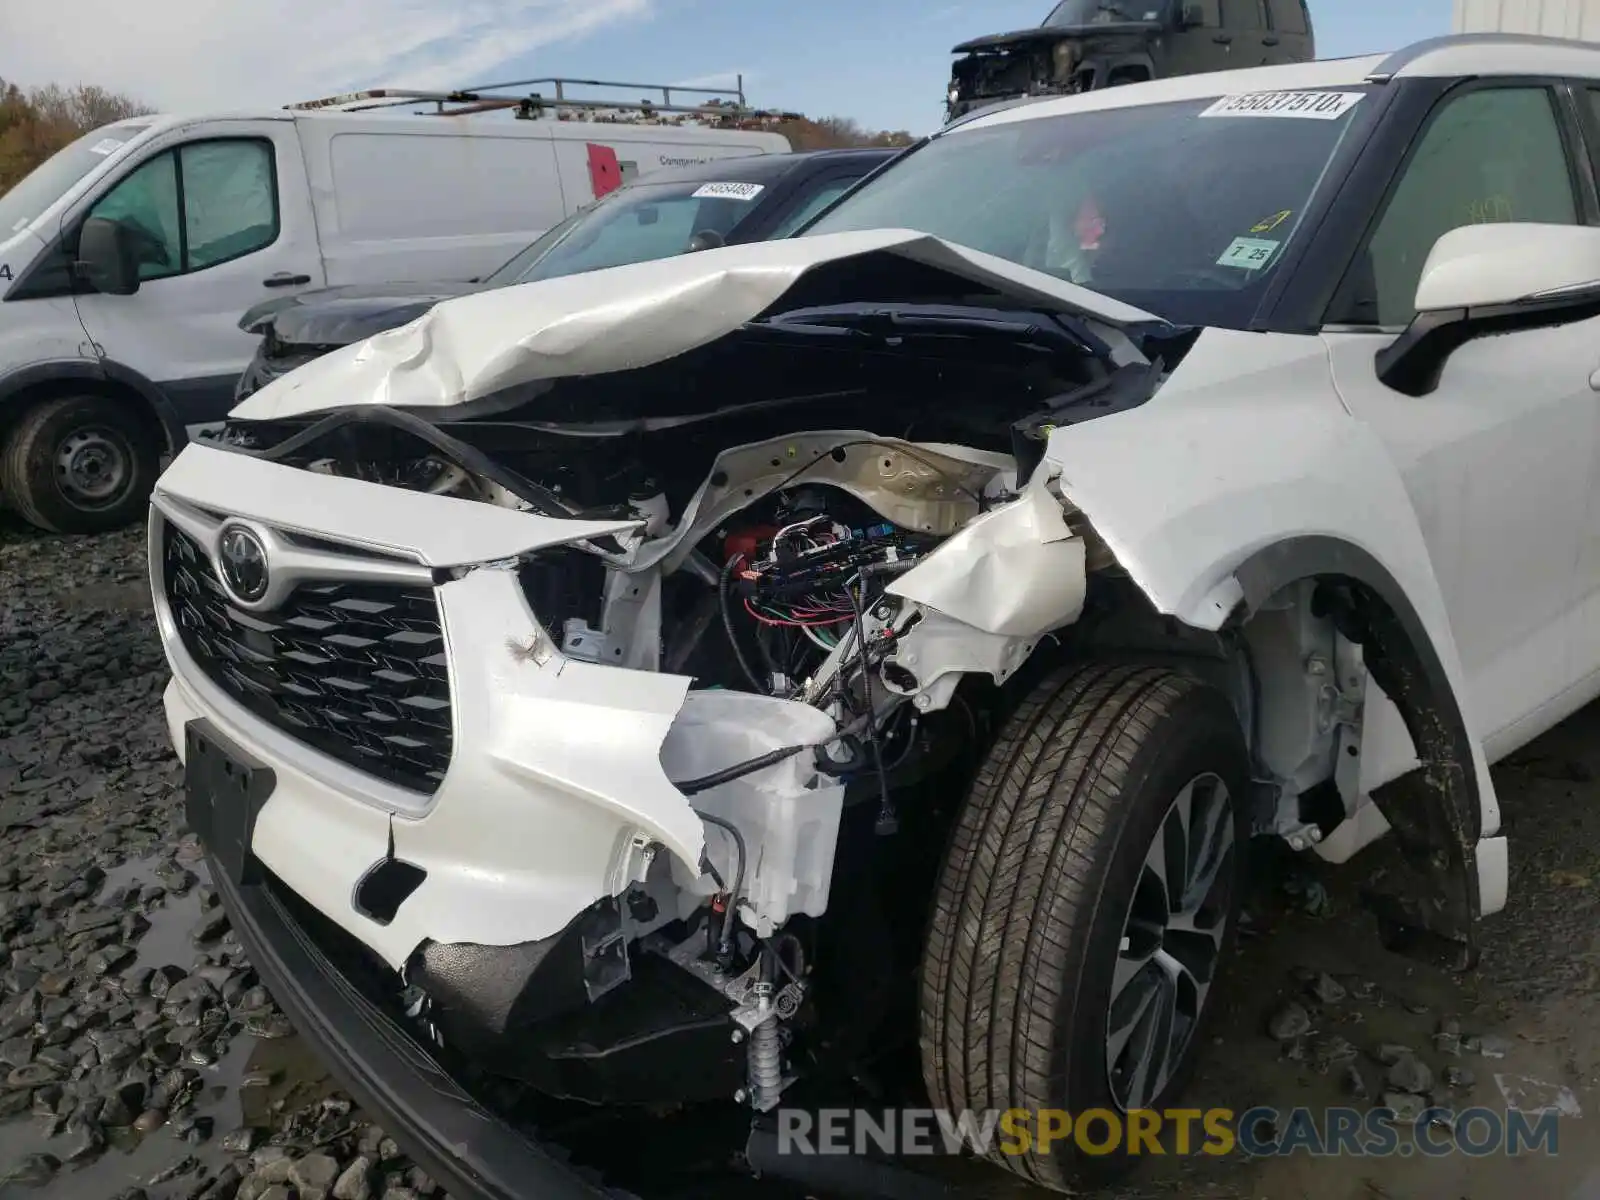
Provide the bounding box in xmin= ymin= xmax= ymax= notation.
xmin=0 ymin=0 xmax=1451 ymax=133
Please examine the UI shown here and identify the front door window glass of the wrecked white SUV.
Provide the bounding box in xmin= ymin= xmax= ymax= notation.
xmin=1330 ymin=88 xmax=1579 ymax=325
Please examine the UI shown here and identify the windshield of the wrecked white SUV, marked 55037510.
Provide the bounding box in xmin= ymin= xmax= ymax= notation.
xmin=803 ymin=88 xmax=1366 ymax=328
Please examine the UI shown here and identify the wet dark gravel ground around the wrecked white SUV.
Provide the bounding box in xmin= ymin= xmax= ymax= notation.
xmin=0 ymin=515 xmax=1600 ymax=1200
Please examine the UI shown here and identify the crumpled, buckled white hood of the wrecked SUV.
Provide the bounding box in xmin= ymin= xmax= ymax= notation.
xmin=234 ymin=229 xmax=1162 ymax=419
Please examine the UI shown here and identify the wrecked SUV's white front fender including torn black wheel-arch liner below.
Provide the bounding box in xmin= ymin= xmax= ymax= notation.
xmin=1045 ymin=330 xmax=1499 ymax=966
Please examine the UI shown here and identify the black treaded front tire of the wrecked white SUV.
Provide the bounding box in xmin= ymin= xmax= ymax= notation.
xmin=922 ymin=664 xmax=1250 ymax=1190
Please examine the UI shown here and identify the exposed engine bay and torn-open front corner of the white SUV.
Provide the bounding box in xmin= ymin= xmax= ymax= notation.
xmin=200 ymin=294 xmax=1195 ymax=1110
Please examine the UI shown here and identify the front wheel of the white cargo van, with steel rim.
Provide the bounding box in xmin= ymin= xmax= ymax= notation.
xmin=0 ymin=395 xmax=160 ymax=533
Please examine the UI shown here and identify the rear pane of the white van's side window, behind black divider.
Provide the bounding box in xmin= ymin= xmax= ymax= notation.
xmin=178 ymin=139 xmax=278 ymax=270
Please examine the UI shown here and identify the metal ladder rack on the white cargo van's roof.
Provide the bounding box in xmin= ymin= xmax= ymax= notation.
xmin=283 ymin=75 xmax=800 ymax=126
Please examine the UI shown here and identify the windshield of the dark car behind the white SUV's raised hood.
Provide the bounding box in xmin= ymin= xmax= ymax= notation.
xmin=488 ymin=182 xmax=766 ymax=286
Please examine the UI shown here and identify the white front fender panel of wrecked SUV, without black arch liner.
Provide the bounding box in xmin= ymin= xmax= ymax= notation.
xmin=1045 ymin=330 xmax=1499 ymax=838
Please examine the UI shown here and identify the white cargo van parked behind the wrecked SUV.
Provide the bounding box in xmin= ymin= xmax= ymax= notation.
xmin=0 ymin=83 xmax=789 ymax=533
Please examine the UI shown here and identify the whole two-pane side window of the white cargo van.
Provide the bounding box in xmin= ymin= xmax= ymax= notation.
xmin=90 ymin=138 xmax=278 ymax=280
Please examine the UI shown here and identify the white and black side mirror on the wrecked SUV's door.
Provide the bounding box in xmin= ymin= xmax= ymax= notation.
xmin=1378 ymin=222 xmax=1600 ymax=395
